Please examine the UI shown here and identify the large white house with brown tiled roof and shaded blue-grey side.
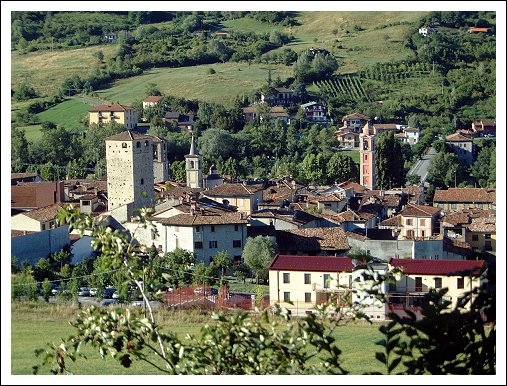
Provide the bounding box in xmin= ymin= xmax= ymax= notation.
xmin=155 ymin=207 xmax=248 ymax=264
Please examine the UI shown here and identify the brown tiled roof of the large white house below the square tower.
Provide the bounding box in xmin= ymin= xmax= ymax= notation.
xmin=158 ymin=209 xmax=248 ymax=226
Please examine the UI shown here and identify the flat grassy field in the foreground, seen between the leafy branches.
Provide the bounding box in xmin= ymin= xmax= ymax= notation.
xmin=11 ymin=304 xmax=382 ymax=375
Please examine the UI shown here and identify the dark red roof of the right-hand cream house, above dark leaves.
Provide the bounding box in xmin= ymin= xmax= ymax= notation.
xmin=389 ymin=258 xmax=485 ymax=276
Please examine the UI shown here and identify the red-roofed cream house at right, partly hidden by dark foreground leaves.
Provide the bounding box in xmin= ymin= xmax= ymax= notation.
xmin=388 ymin=259 xmax=486 ymax=312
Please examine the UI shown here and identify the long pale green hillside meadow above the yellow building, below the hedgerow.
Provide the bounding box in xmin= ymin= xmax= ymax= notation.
xmin=97 ymin=62 xmax=291 ymax=105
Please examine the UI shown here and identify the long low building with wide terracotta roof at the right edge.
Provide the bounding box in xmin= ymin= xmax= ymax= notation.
xmin=433 ymin=188 xmax=496 ymax=212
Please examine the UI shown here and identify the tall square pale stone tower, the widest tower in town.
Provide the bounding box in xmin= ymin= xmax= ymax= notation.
xmin=106 ymin=130 xmax=154 ymax=215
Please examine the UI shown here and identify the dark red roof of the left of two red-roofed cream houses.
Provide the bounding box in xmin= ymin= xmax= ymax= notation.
xmin=269 ymin=255 xmax=354 ymax=272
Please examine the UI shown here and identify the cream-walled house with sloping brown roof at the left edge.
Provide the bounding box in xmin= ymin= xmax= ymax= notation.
xmin=11 ymin=203 xmax=63 ymax=232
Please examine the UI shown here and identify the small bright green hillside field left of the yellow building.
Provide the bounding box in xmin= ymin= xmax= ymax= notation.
xmin=37 ymin=99 xmax=91 ymax=129
